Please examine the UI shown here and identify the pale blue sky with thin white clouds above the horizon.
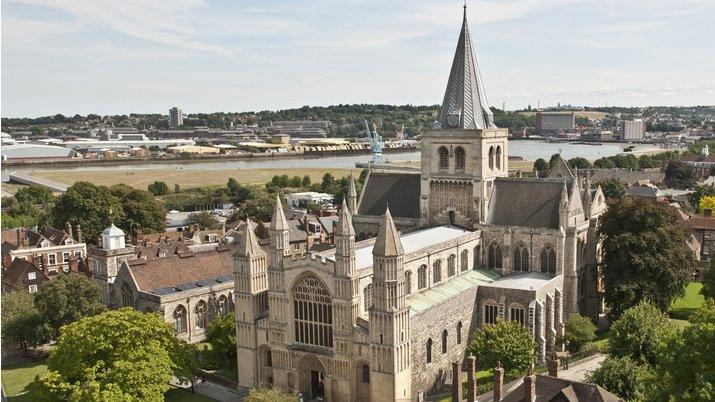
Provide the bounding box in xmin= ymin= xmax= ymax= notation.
xmin=0 ymin=0 xmax=715 ymax=117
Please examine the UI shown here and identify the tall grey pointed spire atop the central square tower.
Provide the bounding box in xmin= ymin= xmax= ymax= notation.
xmin=437 ymin=4 xmax=496 ymax=129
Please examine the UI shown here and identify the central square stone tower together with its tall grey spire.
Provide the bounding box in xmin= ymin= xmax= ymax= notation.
xmin=420 ymin=6 xmax=509 ymax=228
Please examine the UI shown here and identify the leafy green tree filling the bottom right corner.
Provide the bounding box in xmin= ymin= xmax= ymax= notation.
xmin=654 ymin=300 xmax=715 ymax=401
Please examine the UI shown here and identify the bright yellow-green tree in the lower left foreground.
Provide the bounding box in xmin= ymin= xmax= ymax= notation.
xmin=35 ymin=308 xmax=196 ymax=401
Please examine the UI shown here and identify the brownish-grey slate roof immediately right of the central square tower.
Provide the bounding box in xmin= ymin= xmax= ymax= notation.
xmin=487 ymin=178 xmax=573 ymax=229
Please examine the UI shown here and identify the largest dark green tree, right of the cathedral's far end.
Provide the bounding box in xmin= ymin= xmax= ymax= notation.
xmin=598 ymin=199 xmax=694 ymax=317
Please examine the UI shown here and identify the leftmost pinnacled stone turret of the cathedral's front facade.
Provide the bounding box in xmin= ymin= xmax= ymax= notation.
xmin=233 ymin=219 xmax=268 ymax=387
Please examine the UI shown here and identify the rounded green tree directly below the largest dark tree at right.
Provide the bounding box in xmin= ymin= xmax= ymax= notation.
xmin=608 ymin=302 xmax=673 ymax=364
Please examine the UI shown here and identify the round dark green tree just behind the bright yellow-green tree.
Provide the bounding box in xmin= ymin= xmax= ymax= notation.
xmin=35 ymin=273 xmax=106 ymax=338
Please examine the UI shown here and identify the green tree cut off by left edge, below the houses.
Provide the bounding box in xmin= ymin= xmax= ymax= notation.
xmin=2 ymin=291 xmax=49 ymax=353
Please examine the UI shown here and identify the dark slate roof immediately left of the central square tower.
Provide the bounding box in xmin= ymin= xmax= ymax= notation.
xmin=358 ymin=172 xmax=420 ymax=218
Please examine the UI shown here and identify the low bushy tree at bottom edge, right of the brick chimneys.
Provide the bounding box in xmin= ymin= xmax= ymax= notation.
xmin=586 ymin=356 xmax=650 ymax=401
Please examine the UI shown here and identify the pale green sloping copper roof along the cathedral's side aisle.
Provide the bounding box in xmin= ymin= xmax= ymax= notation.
xmin=407 ymin=269 xmax=501 ymax=315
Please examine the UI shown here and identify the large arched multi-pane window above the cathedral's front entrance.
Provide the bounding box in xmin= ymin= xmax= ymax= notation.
xmin=293 ymin=275 xmax=333 ymax=348
